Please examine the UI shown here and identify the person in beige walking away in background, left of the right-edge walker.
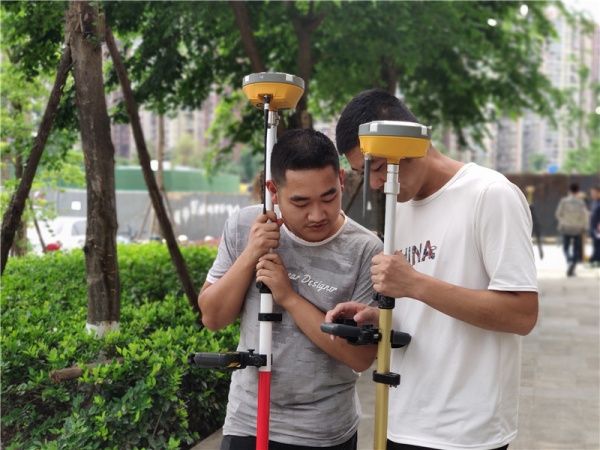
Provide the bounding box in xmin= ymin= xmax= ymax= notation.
xmin=554 ymin=183 xmax=589 ymax=277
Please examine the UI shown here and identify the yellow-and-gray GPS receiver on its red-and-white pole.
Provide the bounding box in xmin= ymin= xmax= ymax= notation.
xmin=242 ymin=72 xmax=304 ymax=450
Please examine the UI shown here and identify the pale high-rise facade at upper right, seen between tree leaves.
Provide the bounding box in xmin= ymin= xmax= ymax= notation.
xmin=491 ymin=7 xmax=600 ymax=173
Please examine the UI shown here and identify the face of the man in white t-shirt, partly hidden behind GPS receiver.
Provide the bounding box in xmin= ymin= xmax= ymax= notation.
xmin=345 ymin=146 xmax=422 ymax=202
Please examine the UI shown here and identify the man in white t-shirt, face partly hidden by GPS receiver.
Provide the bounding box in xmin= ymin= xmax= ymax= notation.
xmin=326 ymin=90 xmax=538 ymax=450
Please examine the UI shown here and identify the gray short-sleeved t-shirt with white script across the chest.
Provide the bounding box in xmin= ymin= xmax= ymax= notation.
xmin=207 ymin=205 xmax=383 ymax=447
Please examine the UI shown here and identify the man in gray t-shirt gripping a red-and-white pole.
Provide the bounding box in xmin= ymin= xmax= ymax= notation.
xmin=198 ymin=130 xmax=382 ymax=450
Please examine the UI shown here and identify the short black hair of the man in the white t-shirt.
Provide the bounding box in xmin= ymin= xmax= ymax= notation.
xmin=335 ymin=89 xmax=419 ymax=155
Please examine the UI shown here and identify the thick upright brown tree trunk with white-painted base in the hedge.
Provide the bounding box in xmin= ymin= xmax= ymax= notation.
xmin=66 ymin=0 xmax=121 ymax=337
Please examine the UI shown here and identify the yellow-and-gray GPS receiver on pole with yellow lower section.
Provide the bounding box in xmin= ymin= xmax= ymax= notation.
xmin=358 ymin=120 xmax=431 ymax=450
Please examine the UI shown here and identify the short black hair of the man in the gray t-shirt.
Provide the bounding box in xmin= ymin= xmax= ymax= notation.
xmin=271 ymin=129 xmax=340 ymax=187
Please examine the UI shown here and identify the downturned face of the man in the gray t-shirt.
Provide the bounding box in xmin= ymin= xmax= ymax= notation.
xmin=267 ymin=166 xmax=344 ymax=242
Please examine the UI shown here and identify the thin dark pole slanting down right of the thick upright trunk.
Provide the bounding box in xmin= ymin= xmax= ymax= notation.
xmin=106 ymin=29 xmax=201 ymax=314
